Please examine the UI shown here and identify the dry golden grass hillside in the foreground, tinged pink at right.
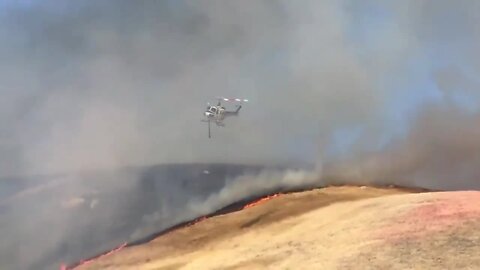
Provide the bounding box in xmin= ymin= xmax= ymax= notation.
xmin=78 ymin=186 xmax=480 ymax=270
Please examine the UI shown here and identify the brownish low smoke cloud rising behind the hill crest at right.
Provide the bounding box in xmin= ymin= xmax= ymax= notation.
xmin=324 ymin=104 xmax=480 ymax=190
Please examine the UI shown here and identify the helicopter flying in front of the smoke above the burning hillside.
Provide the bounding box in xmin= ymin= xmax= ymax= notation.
xmin=202 ymin=97 xmax=248 ymax=138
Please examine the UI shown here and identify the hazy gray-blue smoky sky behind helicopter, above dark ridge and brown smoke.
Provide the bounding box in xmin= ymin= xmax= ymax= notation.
xmin=0 ymin=0 xmax=480 ymax=178
